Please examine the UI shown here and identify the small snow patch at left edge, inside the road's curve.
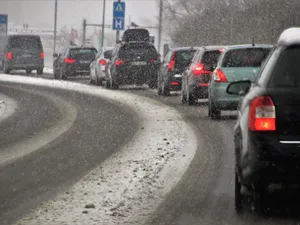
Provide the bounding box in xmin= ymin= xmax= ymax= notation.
xmin=0 ymin=94 xmax=18 ymax=123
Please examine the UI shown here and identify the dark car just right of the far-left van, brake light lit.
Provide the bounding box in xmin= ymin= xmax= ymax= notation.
xmin=53 ymin=47 xmax=97 ymax=79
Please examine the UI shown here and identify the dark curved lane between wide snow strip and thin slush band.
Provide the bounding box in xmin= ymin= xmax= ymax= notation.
xmin=0 ymin=85 xmax=139 ymax=224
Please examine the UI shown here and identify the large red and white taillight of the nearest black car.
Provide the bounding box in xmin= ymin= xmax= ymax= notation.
xmin=248 ymin=96 xmax=276 ymax=131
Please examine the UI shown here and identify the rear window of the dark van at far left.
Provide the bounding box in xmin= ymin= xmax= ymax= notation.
xmin=9 ymin=36 xmax=42 ymax=49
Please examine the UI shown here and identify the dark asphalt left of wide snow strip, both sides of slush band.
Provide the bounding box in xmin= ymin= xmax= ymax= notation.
xmin=0 ymin=83 xmax=139 ymax=225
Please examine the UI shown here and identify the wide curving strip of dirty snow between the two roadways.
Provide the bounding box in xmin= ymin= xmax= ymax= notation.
xmin=0 ymin=76 xmax=197 ymax=225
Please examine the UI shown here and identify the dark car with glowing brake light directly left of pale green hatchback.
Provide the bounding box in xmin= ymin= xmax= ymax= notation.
xmin=181 ymin=46 xmax=224 ymax=105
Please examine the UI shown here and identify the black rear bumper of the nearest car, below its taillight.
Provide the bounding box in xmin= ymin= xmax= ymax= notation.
xmin=241 ymin=132 xmax=300 ymax=187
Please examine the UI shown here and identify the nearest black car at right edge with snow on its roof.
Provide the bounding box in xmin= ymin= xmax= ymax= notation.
xmin=227 ymin=28 xmax=300 ymax=213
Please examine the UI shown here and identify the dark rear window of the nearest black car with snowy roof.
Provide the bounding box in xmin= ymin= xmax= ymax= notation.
xmin=269 ymin=46 xmax=300 ymax=88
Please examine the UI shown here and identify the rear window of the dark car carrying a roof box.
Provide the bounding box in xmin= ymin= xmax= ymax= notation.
xmin=119 ymin=44 xmax=157 ymax=59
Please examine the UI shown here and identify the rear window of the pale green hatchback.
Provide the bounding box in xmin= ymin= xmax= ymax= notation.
xmin=222 ymin=48 xmax=271 ymax=67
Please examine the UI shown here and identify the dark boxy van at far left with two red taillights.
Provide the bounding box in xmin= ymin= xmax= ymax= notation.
xmin=0 ymin=34 xmax=44 ymax=75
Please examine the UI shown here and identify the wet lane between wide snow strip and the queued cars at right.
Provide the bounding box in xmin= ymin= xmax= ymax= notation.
xmin=127 ymin=89 xmax=299 ymax=225
